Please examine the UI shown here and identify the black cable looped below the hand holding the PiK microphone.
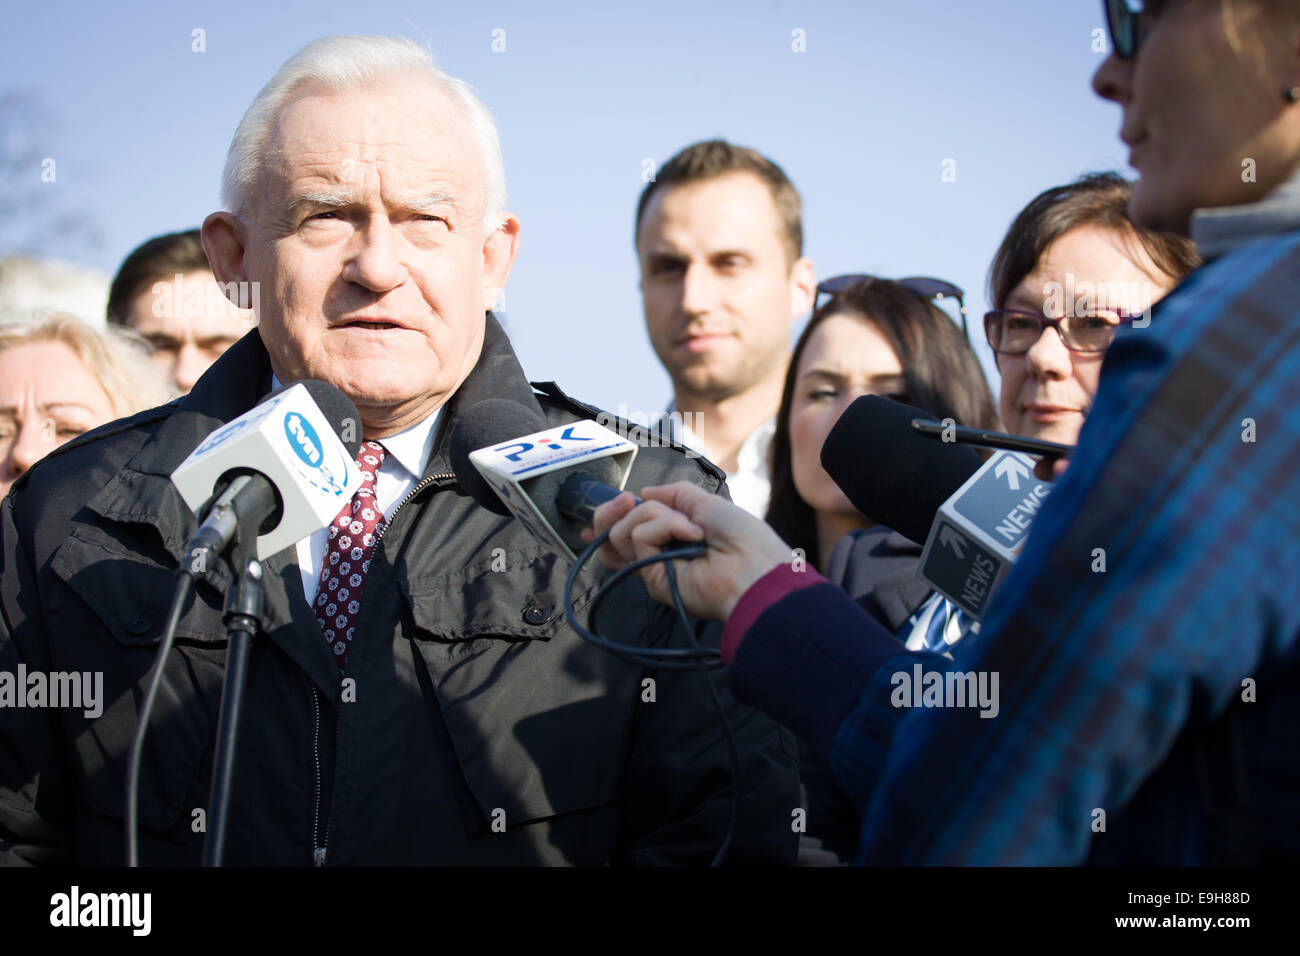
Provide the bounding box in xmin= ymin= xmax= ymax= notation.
xmin=564 ymin=531 xmax=740 ymax=866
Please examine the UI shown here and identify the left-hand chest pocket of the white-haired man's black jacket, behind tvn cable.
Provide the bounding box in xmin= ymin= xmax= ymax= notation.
xmin=48 ymin=527 xmax=226 ymax=840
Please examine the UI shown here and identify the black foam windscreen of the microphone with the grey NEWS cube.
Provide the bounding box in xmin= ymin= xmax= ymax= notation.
xmin=822 ymin=395 xmax=984 ymax=545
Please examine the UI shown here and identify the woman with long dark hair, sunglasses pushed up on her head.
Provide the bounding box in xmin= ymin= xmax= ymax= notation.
xmin=767 ymin=276 xmax=997 ymax=865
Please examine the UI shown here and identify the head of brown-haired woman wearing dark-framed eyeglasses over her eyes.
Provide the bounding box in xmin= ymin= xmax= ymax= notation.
xmin=984 ymin=173 xmax=1200 ymax=445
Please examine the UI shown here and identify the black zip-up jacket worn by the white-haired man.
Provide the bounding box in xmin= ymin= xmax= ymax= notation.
xmin=0 ymin=313 xmax=798 ymax=865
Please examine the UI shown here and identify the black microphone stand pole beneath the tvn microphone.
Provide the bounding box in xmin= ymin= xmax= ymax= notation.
xmin=203 ymin=542 xmax=265 ymax=866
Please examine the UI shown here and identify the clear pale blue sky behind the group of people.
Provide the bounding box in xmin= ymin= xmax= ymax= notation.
xmin=0 ymin=0 xmax=1131 ymax=410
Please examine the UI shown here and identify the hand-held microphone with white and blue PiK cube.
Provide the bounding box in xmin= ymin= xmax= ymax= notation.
xmin=450 ymin=398 xmax=637 ymax=561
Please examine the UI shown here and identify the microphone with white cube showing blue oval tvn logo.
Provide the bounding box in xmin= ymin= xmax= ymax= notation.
xmin=172 ymin=381 xmax=361 ymax=575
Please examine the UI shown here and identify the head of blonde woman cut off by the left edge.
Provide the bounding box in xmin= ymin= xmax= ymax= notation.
xmin=0 ymin=313 xmax=170 ymax=496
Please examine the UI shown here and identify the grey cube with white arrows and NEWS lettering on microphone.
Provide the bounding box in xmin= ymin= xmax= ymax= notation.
xmin=920 ymin=451 xmax=1052 ymax=620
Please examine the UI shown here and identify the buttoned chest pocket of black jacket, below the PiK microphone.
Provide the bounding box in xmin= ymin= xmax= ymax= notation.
xmin=404 ymin=551 xmax=640 ymax=829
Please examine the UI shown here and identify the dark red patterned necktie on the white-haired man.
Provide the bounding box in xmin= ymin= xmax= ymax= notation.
xmin=316 ymin=441 xmax=387 ymax=670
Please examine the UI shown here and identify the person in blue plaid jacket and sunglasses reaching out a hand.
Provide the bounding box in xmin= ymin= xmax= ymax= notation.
xmin=594 ymin=0 xmax=1300 ymax=866
